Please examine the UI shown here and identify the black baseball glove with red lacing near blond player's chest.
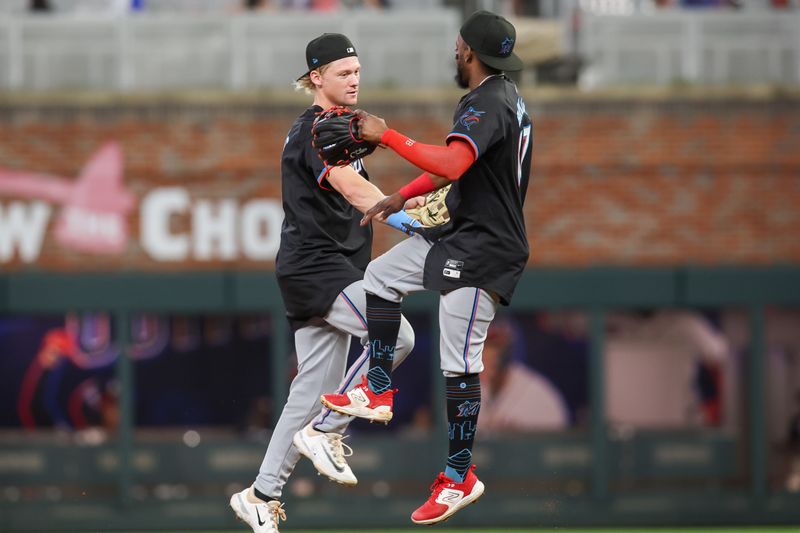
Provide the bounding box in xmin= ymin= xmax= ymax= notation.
xmin=311 ymin=106 xmax=376 ymax=167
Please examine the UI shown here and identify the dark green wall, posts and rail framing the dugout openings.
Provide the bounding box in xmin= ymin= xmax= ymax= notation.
xmin=0 ymin=267 xmax=800 ymax=531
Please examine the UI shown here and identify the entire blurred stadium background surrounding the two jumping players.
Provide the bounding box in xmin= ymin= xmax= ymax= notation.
xmin=0 ymin=0 xmax=800 ymax=531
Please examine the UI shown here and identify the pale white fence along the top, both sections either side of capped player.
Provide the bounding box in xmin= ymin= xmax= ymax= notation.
xmin=0 ymin=8 xmax=800 ymax=91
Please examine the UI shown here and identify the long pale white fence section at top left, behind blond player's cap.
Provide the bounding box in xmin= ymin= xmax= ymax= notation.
xmin=0 ymin=9 xmax=460 ymax=91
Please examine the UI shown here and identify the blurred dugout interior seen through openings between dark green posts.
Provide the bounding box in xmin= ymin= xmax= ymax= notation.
xmin=9 ymin=309 xmax=800 ymax=440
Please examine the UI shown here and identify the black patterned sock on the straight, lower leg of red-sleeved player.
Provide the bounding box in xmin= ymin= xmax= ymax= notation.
xmin=444 ymin=374 xmax=481 ymax=482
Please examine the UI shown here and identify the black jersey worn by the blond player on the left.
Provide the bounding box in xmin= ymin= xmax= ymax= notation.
xmin=275 ymin=106 xmax=372 ymax=321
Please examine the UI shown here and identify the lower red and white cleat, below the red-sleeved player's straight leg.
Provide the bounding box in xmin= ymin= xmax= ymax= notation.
xmin=411 ymin=465 xmax=484 ymax=525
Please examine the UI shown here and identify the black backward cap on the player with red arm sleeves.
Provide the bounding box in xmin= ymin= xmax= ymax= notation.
xmin=461 ymin=11 xmax=523 ymax=72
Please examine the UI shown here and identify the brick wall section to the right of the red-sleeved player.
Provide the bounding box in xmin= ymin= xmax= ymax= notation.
xmin=529 ymin=98 xmax=800 ymax=264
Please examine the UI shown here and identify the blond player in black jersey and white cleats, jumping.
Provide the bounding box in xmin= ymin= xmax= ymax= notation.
xmin=230 ymin=33 xmax=422 ymax=533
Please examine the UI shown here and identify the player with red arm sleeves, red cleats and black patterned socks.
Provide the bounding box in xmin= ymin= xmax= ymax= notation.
xmin=322 ymin=11 xmax=531 ymax=524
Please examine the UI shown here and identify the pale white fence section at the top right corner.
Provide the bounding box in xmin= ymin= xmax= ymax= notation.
xmin=578 ymin=10 xmax=800 ymax=88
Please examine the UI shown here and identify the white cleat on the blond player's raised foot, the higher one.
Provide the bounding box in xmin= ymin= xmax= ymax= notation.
xmin=292 ymin=422 xmax=358 ymax=485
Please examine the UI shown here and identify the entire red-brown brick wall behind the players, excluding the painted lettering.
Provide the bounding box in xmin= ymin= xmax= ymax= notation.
xmin=0 ymin=93 xmax=800 ymax=269
